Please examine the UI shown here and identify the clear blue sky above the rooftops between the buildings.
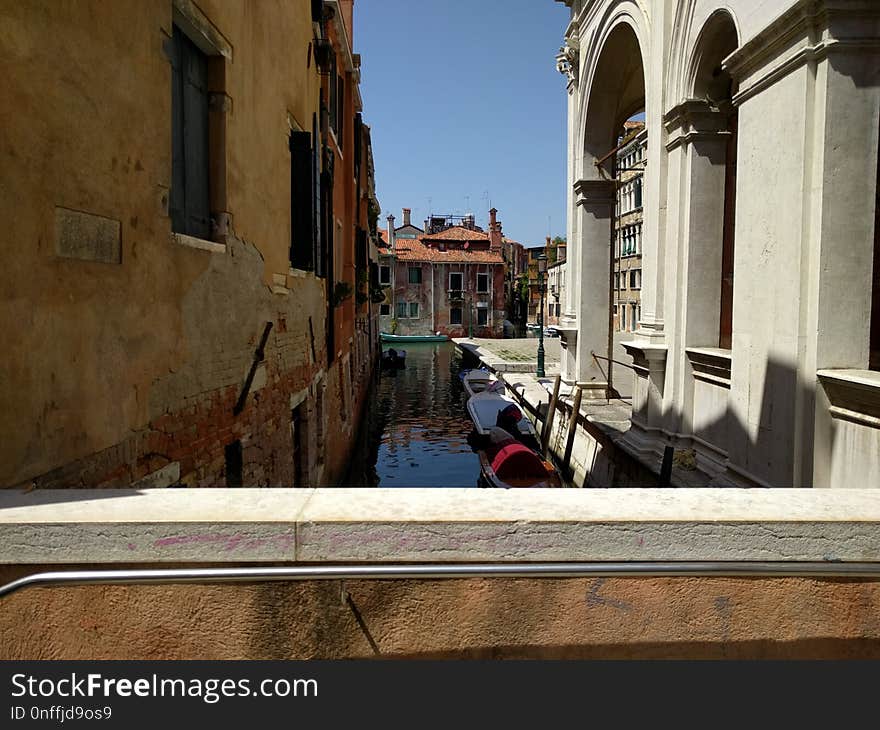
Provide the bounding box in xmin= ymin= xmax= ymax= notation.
xmin=353 ymin=0 xmax=569 ymax=246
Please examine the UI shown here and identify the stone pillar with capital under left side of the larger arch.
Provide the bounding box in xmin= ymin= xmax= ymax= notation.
xmin=572 ymin=180 xmax=615 ymax=398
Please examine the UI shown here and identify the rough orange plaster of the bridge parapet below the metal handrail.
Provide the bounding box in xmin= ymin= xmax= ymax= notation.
xmin=0 ymin=569 xmax=880 ymax=660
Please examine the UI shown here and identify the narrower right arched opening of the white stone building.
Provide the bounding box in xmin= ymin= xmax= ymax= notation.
xmin=693 ymin=11 xmax=739 ymax=350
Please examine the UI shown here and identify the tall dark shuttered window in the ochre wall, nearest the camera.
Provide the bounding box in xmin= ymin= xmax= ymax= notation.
xmin=169 ymin=25 xmax=211 ymax=238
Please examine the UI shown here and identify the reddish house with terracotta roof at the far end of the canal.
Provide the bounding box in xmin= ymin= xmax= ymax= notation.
xmin=379 ymin=208 xmax=505 ymax=337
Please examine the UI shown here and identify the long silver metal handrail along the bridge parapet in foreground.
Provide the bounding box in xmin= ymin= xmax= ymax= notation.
xmin=0 ymin=560 xmax=880 ymax=598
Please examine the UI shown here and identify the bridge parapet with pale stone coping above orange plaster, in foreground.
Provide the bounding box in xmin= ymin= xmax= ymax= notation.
xmin=0 ymin=489 xmax=880 ymax=660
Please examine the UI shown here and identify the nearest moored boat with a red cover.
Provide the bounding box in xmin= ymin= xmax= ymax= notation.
xmin=475 ymin=427 xmax=562 ymax=489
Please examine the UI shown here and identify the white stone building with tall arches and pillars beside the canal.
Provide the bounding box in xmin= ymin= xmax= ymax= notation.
xmin=557 ymin=0 xmax=880 ymax=487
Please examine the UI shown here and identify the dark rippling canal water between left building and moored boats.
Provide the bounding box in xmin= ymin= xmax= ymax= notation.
xmin=344 ymin=342 xmax=480 ymax=487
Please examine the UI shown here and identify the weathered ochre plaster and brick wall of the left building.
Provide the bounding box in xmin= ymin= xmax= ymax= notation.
xmin=0 ymin=0 xmax=363 ymax=486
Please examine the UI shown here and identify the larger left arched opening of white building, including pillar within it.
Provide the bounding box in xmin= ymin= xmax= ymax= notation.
xmin=575 ymin=21 xmax=647 ymax=393
